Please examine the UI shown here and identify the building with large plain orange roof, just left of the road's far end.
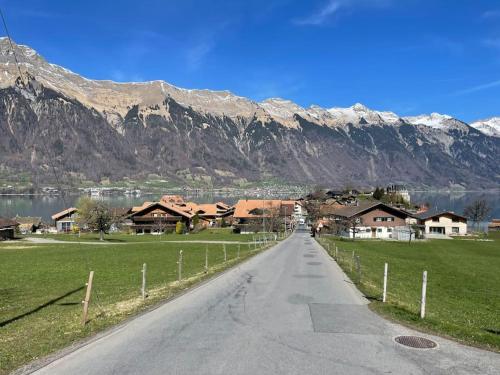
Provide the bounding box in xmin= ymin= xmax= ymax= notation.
xmin=233 ymin=199 xmax=295 ymax=233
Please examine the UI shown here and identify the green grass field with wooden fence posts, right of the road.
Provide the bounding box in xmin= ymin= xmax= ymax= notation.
xmin=320 ymin=233 xmax=500 ymax=352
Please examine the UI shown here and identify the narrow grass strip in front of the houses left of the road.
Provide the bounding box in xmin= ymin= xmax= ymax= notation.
xmin=30 ymin=228 xmax=254 ymax=243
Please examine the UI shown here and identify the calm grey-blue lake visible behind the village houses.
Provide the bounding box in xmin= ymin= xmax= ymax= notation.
xmin=0 ymin=191 xmax=500 ymax=226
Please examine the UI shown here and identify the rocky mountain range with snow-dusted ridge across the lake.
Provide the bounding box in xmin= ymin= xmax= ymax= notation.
xmin=0 ymin=39 xmax=500 ymax=188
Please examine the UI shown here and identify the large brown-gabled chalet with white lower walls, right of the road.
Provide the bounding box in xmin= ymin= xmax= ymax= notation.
xmin=330 ymin=201 xmax=410 ymax=238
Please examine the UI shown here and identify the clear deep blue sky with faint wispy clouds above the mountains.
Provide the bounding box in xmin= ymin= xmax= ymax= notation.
xmin=0 ymin=0 xmax=500 ymax=121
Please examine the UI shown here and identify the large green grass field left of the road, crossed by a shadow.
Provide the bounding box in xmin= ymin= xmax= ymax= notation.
xmin=0 ymin=233 xmax=274 ymax=374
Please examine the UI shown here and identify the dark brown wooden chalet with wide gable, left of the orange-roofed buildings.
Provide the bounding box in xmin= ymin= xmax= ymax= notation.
xmin=127 ymin=202 xmax=194 ymax=234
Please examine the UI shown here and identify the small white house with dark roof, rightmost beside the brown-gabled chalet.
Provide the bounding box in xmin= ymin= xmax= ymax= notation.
xmin=414 ymin=210 xmax=467 ymax=237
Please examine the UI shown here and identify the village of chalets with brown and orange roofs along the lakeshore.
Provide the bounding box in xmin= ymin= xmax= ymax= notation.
xmin=0 ymin=185 xmax=500 ymax=241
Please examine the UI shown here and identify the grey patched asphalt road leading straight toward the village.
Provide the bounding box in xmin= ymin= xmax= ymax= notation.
xmin=31 ymin=233 xmax=500 ymax=375
